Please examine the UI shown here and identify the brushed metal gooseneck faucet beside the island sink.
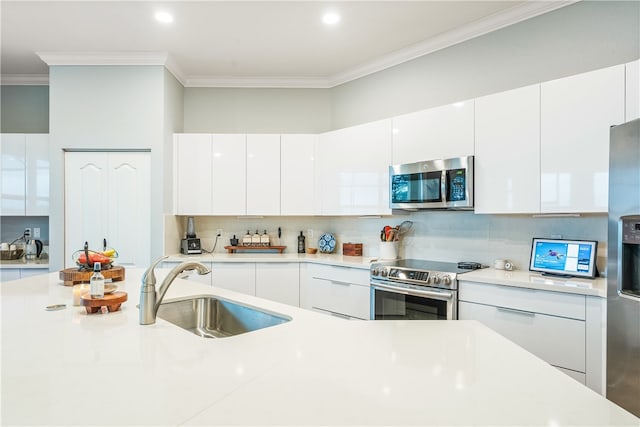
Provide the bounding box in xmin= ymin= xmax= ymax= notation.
xmin=139 ymin=256 xmax=211 ymax=325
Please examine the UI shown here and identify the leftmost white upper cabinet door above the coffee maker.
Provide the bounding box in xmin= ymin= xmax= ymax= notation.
xmin=174 ymin=134 xmax=212 ymax=215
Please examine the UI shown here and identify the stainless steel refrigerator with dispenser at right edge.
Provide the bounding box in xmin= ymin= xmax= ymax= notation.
xmin=607 ymin=119 xmax=640 ymax=417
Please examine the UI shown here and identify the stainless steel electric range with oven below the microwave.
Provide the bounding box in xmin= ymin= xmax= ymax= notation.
xmin=370 ymin=259 xmax=481 ymax=320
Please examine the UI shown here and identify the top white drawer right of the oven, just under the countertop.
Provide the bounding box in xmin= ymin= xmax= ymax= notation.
xmin=458 ymin=281 xmax=586 ymax=320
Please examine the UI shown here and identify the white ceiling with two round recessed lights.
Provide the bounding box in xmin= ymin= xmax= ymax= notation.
xmin=0 ymin=0 xmax=573 ymax=87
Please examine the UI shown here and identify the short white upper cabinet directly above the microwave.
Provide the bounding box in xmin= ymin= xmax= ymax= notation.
xmin=392 ymin=100 xmax=474 ymax=165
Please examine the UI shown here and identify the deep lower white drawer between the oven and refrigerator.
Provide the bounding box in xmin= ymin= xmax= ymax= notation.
xmin=458 ymin=301 xmax=585 ymax=372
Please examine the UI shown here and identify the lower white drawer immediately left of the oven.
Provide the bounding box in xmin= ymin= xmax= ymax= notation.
xmin=310 ymin=278 xmax=370 ymax=320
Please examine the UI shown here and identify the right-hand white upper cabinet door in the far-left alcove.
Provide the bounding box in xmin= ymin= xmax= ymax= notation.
xmin=25 ymin=134 xmax=49 ymax=216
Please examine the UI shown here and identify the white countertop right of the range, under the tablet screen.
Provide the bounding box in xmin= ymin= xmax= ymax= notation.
xmin=458 ymin=268 xmax=607 ymax=298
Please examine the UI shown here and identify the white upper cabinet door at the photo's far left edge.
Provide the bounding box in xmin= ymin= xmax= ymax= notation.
xmin=0 ymin=134 xmax=26 ymax=215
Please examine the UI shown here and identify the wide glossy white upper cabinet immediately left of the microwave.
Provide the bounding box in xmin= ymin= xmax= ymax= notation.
xmin=316 ymin=119 xmax=391 ymax=215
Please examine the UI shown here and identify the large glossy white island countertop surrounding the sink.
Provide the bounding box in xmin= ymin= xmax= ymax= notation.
xmin=0 ymin=270 xmax=640 ymax=427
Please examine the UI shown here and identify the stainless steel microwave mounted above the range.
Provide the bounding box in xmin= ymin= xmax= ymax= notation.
xmin=389 ymin=156 xmax=473 ymax=210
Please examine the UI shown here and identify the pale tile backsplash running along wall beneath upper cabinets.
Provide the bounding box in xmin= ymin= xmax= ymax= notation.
xmin=165 ymin=211 xmax=607 ymax=273
